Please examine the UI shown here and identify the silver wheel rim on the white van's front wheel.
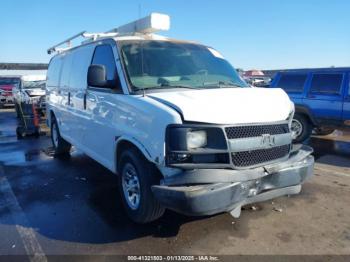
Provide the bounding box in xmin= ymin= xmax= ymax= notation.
xmin=122 ymin=163 xmax=141 ymax=210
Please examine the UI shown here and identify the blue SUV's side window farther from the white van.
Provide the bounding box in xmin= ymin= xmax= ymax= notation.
xmin=310 ymin=74 xmax=343 ymax=94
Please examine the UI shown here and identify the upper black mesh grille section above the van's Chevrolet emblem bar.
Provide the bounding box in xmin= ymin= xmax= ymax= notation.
xmin=225 ymin=123 xmax=289 ymax=139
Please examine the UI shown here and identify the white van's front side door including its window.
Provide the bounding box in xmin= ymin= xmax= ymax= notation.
xmin=84 ymin=42 xmax=123 ymax=170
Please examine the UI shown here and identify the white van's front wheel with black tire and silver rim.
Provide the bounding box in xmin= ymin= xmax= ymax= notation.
xmin=118 ymin=148 xmax=165 ymax=224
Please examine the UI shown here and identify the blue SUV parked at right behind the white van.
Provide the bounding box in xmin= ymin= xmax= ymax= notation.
xmin=270 ymin=69 xmax=350 ymax=142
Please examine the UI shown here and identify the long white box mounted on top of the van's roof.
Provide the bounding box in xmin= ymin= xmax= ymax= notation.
xmin=108 ymin=13 xmax=170 ymax=34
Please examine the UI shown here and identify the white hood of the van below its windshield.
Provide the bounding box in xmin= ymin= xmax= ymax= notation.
xmin=148 ymin=88 xmax=294 ymax=124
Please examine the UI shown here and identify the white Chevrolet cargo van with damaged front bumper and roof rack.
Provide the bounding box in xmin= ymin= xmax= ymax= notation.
xmin=46 ymin=13 xmax=314 ymax=223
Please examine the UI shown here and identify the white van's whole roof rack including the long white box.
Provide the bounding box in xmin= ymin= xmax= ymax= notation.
xmin=47 ymin=13 xmax=170 ymax=54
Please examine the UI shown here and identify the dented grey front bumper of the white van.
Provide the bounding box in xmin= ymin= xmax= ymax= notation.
xmin=152 ymin=145 xmax=314 ymax=216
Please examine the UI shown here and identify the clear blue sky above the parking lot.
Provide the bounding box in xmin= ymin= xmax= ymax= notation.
xmin=0 ymin=0 xmax=350 ymax=69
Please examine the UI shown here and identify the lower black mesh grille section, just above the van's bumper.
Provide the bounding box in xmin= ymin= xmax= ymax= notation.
xmin=231 ymin=144 xmax=290 ymax=167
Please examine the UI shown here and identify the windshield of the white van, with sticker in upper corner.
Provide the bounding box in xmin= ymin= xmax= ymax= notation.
xmin=120 ymin=40 xmax=248 ymax=91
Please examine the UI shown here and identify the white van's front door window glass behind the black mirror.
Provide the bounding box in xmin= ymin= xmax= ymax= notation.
xmin=91 ymin=45 xmax=120 ymax=89
